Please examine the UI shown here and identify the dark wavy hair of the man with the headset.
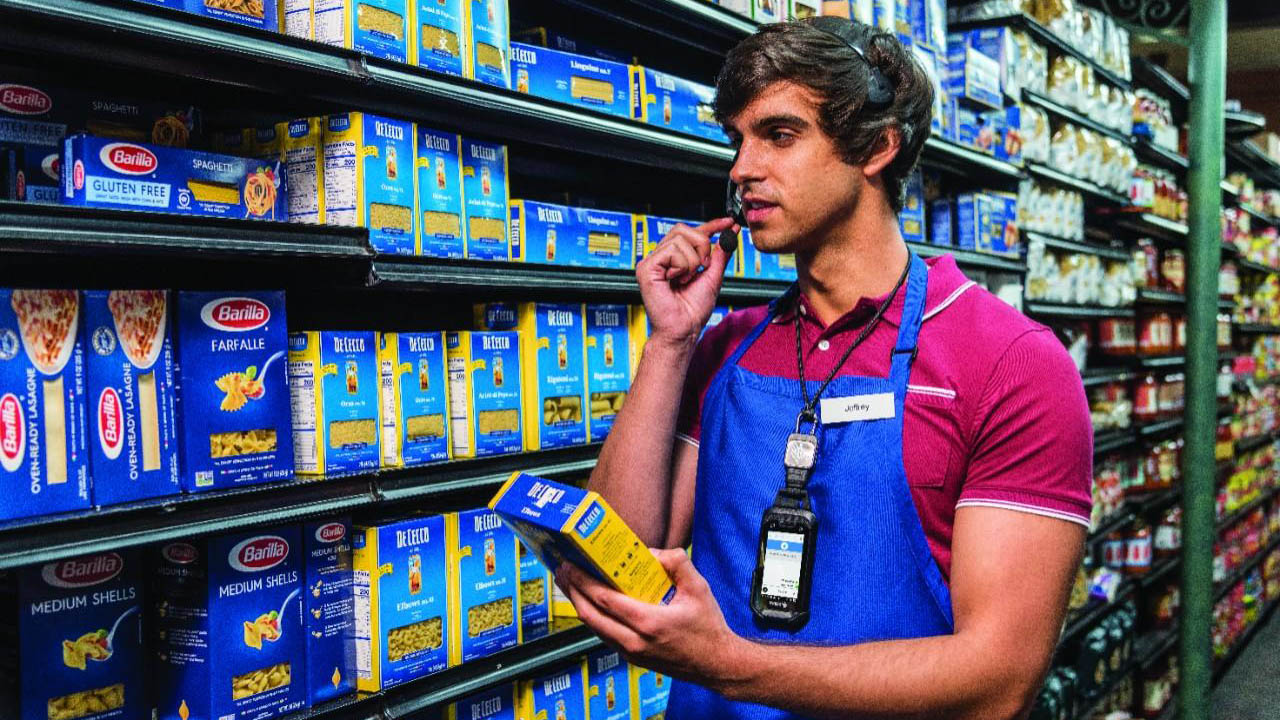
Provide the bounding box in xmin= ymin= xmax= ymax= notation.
xmin=716 ymin=19 xmax=933 ymax=213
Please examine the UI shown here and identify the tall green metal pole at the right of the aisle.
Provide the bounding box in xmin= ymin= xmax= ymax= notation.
xmin=1179 ymin=0 xmax=1226 ymax=720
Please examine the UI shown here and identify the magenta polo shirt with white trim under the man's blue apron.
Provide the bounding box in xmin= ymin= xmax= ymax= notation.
xmin=677 ymin=255 xmax=1093 ymax=579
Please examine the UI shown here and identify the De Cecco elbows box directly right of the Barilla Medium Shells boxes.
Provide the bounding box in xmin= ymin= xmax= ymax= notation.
xmin=352 ymin=515 xmax=451 ymax=692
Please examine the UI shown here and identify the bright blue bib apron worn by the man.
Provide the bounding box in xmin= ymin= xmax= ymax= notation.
xmin=667 ymin=254 xmax=954 ymax=720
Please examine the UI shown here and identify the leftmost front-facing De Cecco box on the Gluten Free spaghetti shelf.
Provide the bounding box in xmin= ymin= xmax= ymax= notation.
xmin=324 ymin=113 xmax=417 ymax=255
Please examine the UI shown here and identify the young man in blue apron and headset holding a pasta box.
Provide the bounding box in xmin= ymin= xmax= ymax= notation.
xmin=557 ymin=18 xmax=1092 ymax=720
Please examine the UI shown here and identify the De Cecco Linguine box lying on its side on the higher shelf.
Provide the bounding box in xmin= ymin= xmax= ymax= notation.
xmin=511 ymin=42 xmax=631 ymax=118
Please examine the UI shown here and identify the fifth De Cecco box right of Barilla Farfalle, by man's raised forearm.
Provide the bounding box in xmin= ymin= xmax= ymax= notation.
xmin=585 ymin=304 xmax=631 ymax=442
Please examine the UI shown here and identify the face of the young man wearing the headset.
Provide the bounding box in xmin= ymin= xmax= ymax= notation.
xmin=727 ymin=82 xmax=864 ymax=252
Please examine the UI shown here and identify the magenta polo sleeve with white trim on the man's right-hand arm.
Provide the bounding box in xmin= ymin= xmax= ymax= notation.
xmin=956 ymin=328 xmax=1093 ymax=527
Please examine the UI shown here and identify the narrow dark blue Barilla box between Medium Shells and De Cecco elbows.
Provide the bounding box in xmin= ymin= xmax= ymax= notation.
xmin=302 ymin=518 xmax=356 ymax=706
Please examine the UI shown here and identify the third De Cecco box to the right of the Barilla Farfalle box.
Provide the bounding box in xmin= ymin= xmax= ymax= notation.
xmin=445 ymin=332 xmax=524 ymax=460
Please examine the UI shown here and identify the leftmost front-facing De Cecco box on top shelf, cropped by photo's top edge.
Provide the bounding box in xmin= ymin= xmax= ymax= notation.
xmin=315 ymin=0 xmax=410 ymax=63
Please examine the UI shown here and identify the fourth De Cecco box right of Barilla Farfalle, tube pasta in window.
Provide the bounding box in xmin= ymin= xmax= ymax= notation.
xmin=476 ymin=302 xmax=586 ymax=452
